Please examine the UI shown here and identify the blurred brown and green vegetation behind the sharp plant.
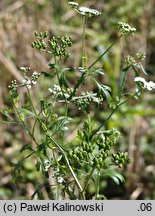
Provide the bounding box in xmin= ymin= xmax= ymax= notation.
xmin=0 ymin=0 xmax=155 ymax=199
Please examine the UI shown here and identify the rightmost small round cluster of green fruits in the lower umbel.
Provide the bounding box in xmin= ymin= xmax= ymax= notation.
xmin=112 ymin=152 xmax=130 ymax=167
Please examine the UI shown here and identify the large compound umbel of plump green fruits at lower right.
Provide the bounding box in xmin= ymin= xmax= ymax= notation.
xmin=68 ymin=117 xmax=130 ymax=170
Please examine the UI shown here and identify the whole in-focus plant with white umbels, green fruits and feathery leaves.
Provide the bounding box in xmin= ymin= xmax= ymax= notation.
xmin=0 ymin=2 xmax=154 ymax=199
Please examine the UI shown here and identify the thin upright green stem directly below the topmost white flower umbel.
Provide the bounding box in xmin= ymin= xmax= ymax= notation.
xmin=82 ymin=16 xmax=87 ymax=68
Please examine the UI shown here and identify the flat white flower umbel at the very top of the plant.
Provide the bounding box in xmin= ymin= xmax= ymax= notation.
xmin=68 ymin=2 xmax=101 ymax=17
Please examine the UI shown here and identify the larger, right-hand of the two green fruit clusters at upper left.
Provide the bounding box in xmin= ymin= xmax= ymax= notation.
xmin=48 ymin=36 xmax=72 ymax=58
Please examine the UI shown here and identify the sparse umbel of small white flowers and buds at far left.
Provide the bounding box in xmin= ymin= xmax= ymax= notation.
xmin=8 ymin=71 xmax=40 ymax=89
